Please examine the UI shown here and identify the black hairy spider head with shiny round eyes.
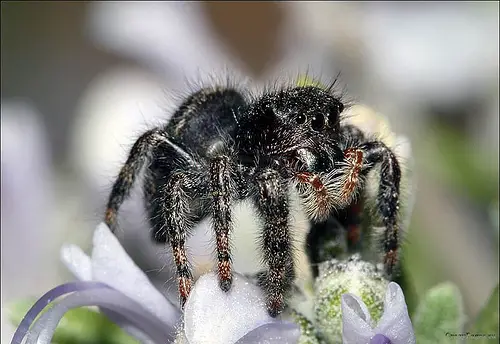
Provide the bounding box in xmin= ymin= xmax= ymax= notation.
xmin=238 ymin=86 xmax=344 ymax=171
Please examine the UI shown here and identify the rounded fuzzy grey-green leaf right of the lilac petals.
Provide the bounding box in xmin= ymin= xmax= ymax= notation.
xmin=413 ymin=283 xmax=465 ymax=344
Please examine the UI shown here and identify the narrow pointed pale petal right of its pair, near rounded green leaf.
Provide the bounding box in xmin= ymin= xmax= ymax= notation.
xmin=375 ymin=282 xmax=416 ymax=344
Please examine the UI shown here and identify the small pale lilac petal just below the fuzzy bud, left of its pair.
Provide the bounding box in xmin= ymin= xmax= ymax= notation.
xmin=341 ymin=293 xmax=375 ymax=344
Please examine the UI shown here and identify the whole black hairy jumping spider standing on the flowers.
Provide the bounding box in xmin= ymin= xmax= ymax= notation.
xmin=105 ymin=82 xmax=401 ymax=317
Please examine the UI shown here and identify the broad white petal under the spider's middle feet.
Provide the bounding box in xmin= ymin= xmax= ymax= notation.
xmin=184 ymin=272 xmax=279 ymax=344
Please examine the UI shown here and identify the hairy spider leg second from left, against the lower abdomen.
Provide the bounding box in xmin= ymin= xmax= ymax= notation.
xmin=143 ymin=140 xmax=204 ymax=307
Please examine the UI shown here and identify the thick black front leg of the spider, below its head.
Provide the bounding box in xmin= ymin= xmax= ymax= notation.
xmin=254 ymin=169 xmax=295 ymax=317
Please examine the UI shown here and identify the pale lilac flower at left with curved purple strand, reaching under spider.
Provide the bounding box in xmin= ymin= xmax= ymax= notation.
xmin=13 ymin=224 xmax=300 ymax=344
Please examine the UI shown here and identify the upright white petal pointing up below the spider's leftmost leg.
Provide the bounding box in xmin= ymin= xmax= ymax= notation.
xmin=92 ymin=223 xmax=179 ymax=324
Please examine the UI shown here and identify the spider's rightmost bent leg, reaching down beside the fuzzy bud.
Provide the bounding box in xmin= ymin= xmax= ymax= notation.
xmin=359 ymin=141 xmax=401 ymax=276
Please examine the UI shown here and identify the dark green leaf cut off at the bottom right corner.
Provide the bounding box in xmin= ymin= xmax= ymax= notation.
xmin=468 ymin=285 xmax=499 ymax=343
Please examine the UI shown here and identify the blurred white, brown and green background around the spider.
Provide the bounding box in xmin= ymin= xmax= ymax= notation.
xmin=1 ymin=1 xmax=499 ymax=342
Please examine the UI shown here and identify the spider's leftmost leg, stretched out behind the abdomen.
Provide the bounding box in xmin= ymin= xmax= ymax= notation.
xmin=104 ymin=129 xmax=165 ymax=232
